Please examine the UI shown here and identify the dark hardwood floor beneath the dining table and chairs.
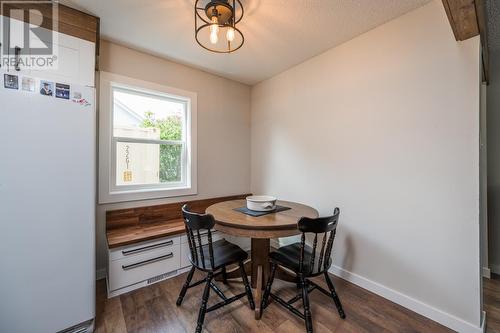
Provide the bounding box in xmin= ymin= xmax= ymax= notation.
xmin=96 ymin=268 xmax=458 ymax=333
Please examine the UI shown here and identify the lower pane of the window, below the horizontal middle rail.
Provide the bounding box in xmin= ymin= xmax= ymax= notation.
xmin=116 ymin=142 xmax=183 ymax=186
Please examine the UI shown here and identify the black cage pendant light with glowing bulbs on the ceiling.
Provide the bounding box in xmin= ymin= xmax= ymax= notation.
xmin=194 ymin=0 xmax=245 ymax=53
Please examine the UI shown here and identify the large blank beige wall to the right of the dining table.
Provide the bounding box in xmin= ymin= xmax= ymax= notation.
xmin=251 ymin=0 xmax=481 ymax=332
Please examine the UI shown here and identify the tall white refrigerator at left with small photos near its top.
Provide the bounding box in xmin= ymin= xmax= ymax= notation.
xmin=0 ymin=77 xmax=96 ymax=333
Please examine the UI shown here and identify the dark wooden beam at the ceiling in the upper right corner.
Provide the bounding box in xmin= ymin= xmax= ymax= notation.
xmin=442 ymin=0 xmax=489 ymax=82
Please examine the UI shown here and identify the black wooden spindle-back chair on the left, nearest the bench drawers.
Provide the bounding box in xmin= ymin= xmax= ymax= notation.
xmin=177 ymin=205 xmax=255 ymax=333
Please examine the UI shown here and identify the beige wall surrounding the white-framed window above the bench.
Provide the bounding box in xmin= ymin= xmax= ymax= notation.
xmin=97 ymin=41 xmax=250 ymax=274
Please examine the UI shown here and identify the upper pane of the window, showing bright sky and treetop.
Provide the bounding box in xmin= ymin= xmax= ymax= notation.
xmin=113 ymin=88 xmax=186 ymax=141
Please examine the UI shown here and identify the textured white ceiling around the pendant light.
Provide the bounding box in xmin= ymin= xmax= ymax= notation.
xmin=63 ymin=0 xmax=429 ymax=84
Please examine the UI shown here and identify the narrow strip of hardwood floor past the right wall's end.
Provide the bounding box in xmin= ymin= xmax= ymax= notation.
xmin=483 ymin=274 xmax=500 ymax=333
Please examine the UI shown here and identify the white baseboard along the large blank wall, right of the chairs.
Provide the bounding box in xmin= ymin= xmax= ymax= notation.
xmin=330 ymin=265 xmax=484 ymax=333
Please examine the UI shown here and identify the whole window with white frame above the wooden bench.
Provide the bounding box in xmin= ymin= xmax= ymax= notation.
xmin=99 ymin=73 xmax=196 ymax=202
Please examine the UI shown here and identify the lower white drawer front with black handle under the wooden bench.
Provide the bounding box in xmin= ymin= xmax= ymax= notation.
xmin=109 ymin=244 xmax=181 ymax=290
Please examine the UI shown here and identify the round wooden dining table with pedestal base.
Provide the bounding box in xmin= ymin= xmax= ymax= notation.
xmin=206 ymin=200 xmax=318 ymax=319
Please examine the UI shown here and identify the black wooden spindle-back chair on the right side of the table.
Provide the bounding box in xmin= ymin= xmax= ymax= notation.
xmin=261 ymin=208 xmax=346 ymax=333
